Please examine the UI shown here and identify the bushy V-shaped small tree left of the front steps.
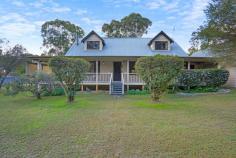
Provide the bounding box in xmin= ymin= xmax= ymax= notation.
xmin=49 ymin=56 xmax=89 ymax=103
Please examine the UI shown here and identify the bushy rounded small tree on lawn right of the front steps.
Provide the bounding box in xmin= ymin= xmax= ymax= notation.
xmin=135 ymin=55 xmax=184 ymax=101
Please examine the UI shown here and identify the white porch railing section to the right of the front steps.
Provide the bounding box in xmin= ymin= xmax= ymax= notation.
xmin=122 ymin=73 xmax=144 ymax=84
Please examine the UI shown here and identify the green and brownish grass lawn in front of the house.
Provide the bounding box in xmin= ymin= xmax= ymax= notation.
xmin=0 ymin=90 xmax=236 ymax=158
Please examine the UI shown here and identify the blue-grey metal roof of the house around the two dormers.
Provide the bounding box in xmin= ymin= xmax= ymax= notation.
xmin=66 ymin=38 xmax=188 ymax=57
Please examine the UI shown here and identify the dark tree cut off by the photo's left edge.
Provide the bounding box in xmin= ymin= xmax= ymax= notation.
xmin=0 ymin=42 xmax=27 ymax=89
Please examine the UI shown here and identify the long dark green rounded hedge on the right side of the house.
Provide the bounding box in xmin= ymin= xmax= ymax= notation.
xmin=176 ymin=69 xmax=229 ymax=89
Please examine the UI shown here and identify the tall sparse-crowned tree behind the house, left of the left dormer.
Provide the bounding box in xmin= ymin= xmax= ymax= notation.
xmin=41 ymin=19 xmax=84 ymax=55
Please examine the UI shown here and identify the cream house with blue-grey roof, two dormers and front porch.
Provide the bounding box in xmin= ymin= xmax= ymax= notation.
xmin=26 ymin=31 xmax=236 ymax=94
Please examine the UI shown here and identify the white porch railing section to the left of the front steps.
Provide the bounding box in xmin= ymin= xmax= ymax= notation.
xmin=83 ymin=73 xmax=112 ymax=84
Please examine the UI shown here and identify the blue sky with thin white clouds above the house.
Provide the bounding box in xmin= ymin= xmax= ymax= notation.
xmin=0 ymin=0 xmax=209 ymax=55
